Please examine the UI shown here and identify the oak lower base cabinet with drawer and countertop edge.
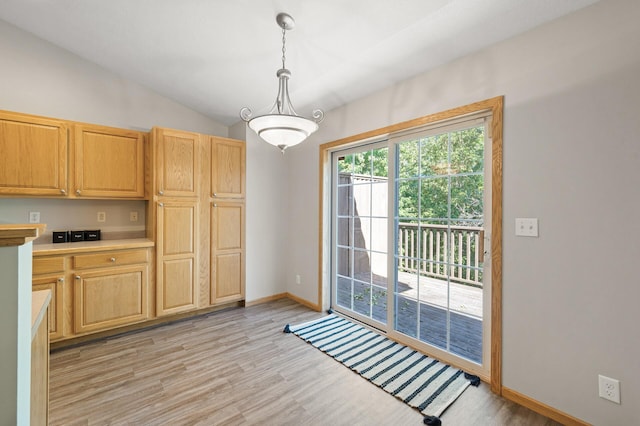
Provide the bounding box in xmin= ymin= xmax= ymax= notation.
xmin=32 ymin=240 xmax=153 ymax=342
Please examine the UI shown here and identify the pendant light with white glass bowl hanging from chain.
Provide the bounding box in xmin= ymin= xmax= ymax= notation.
xmin=240 ymin=13 xmax=324 ymax=154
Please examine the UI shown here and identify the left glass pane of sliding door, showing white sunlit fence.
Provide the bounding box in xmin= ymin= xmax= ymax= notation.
xmin=333 ymin=146 xmax=389 ymax=323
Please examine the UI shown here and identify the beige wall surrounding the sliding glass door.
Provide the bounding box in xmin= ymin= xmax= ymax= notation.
xmin=286 ymin=0 xmax=640 ymax=425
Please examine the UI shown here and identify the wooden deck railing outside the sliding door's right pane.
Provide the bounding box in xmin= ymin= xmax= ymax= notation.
xmin=398 ymin=222 xmax=484 ymax=287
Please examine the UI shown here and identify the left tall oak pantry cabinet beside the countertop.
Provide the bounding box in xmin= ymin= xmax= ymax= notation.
xmin=147 ymin=127 xmax=201 ymax=317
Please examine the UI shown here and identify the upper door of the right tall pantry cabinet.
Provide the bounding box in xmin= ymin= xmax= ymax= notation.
xmin=211 ymin=137 xmax=246 ymax=198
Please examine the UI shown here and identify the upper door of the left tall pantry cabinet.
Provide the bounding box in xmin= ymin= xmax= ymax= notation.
xmin=152 ymin=127 xmax=200 ymax=197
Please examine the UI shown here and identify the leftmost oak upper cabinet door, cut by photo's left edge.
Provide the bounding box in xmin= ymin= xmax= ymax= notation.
xmin=0 ymin=112 xmax=68 ymax=196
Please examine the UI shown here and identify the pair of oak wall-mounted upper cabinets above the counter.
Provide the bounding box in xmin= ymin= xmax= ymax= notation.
xmin=0 ymin=111 xmax=147 ymax=199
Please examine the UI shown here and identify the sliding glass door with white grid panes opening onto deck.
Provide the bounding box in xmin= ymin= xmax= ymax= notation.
xmin=332 ymin=118 xmax=491 ymax=374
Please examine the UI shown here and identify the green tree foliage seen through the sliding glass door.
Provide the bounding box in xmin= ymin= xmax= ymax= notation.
xmin=338 ymin=126 xmax=484 ymax=286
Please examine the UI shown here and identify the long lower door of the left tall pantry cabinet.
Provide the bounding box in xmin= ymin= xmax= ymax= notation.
xmin=156 ymin=200 xmax=198 ymax=316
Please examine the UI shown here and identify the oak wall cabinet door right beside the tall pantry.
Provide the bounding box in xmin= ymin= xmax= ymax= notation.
xmin=72 ymin=125 xmax=145 ymax=199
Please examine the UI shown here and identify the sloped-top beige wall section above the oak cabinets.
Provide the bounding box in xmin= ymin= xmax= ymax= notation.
xmin=0 ymin=21 xmax=228 ymax=136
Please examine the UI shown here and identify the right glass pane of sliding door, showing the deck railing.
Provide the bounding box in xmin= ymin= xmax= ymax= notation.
xmin=394 ymin=126 xmax=484 ymax=363
